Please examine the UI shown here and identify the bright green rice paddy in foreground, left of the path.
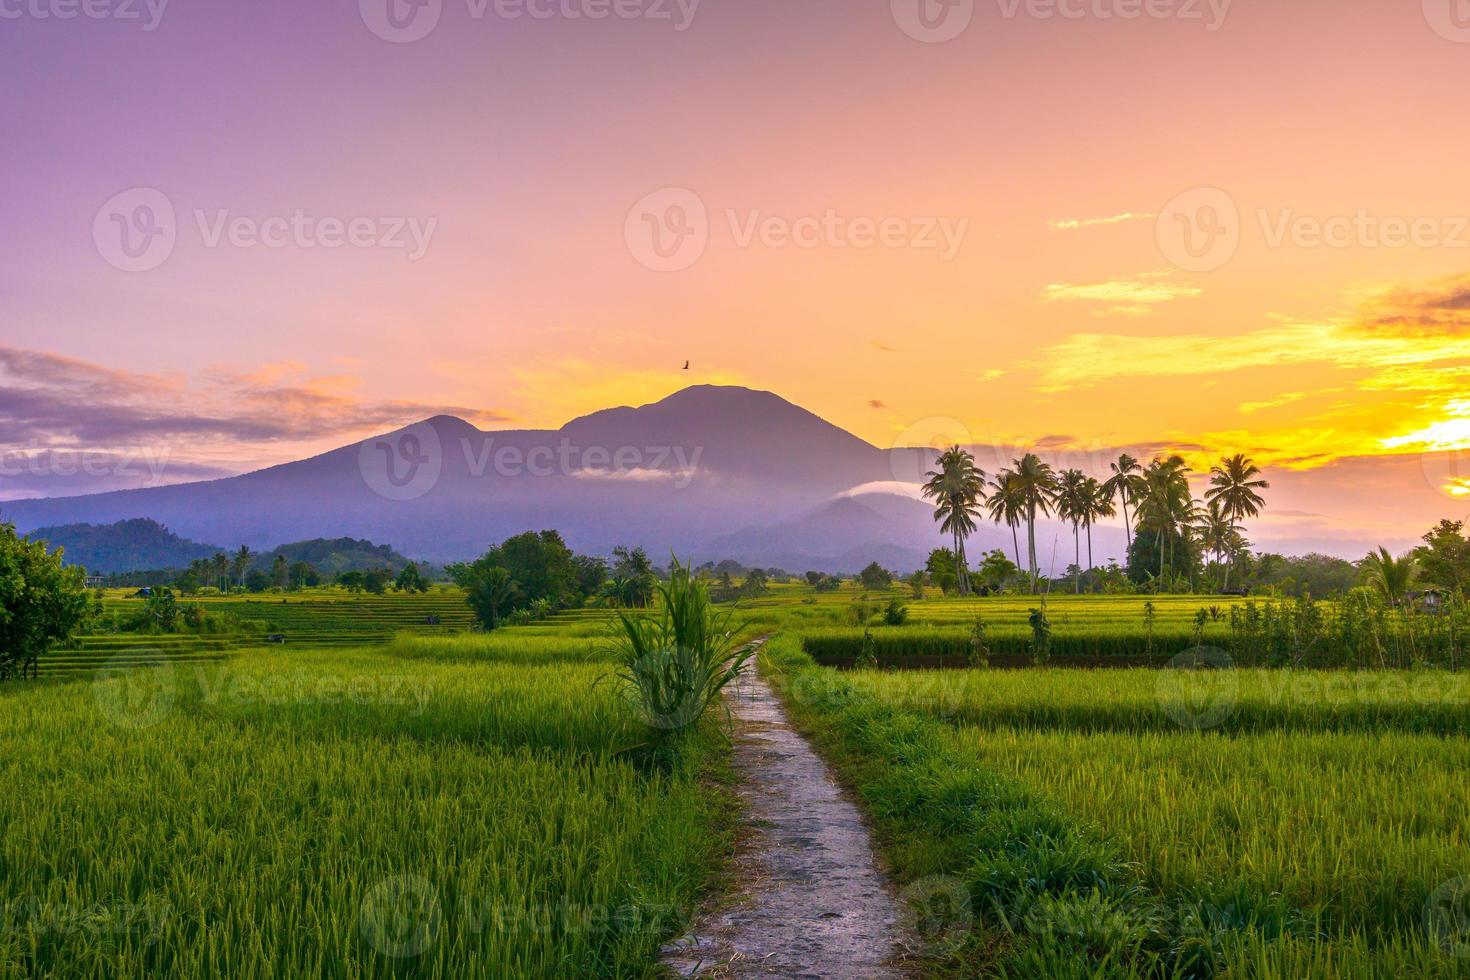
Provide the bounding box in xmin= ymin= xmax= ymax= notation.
xmin=0 ymin=636 xmax=725 ymax=977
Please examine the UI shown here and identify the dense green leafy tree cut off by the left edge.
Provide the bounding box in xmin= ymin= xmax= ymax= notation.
xmin=0 ymin=525 xmax=90 ymax=680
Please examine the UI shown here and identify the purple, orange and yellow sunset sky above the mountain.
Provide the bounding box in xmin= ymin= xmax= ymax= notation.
xmin=0 ymin=0 xmax=1470 ymax=554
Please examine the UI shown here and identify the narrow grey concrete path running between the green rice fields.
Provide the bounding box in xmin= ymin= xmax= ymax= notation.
xmin=664 ymin=643 xmax=903 ymax=979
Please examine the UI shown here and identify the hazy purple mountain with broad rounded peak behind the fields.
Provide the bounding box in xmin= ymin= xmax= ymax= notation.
xmin=3 ymin=386 xmax=913 ymax=564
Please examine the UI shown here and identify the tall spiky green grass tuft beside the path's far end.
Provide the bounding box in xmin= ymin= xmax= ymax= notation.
xmin=613 ymin=560 xmax=754 ymax=733
